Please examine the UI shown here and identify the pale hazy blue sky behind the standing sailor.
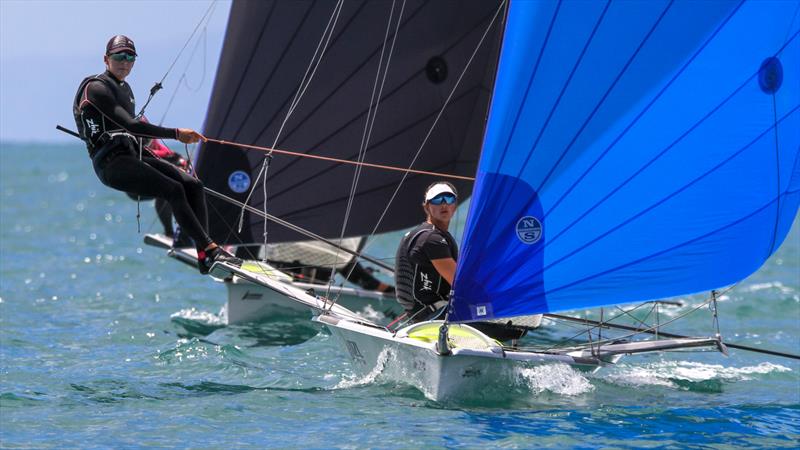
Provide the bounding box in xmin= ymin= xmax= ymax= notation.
xmin=0 ymin=0 xmax=230 ymax=141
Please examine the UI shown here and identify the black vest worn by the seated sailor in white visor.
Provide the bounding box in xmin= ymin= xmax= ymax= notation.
xmin=395 ymin=222 xmax=458 ymax=313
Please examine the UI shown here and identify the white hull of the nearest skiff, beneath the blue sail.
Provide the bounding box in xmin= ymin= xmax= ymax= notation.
xmin=315 ymin=314 xmax=719 ymax=401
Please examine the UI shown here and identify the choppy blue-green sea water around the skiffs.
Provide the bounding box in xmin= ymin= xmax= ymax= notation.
xmin=0 ymin=143 xmax=800 ymax=448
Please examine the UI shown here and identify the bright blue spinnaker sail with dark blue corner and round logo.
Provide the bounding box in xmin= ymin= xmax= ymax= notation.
xmin=450 ymin=1 xmax=800 ymax=321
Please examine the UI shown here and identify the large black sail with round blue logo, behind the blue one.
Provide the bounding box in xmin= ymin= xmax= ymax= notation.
xmin=196 ymin=0 xmax=503 ymax=244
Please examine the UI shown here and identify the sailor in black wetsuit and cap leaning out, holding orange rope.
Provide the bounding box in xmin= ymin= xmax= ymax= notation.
xmin=73 ymin=35 xmax=241 ymax=273
